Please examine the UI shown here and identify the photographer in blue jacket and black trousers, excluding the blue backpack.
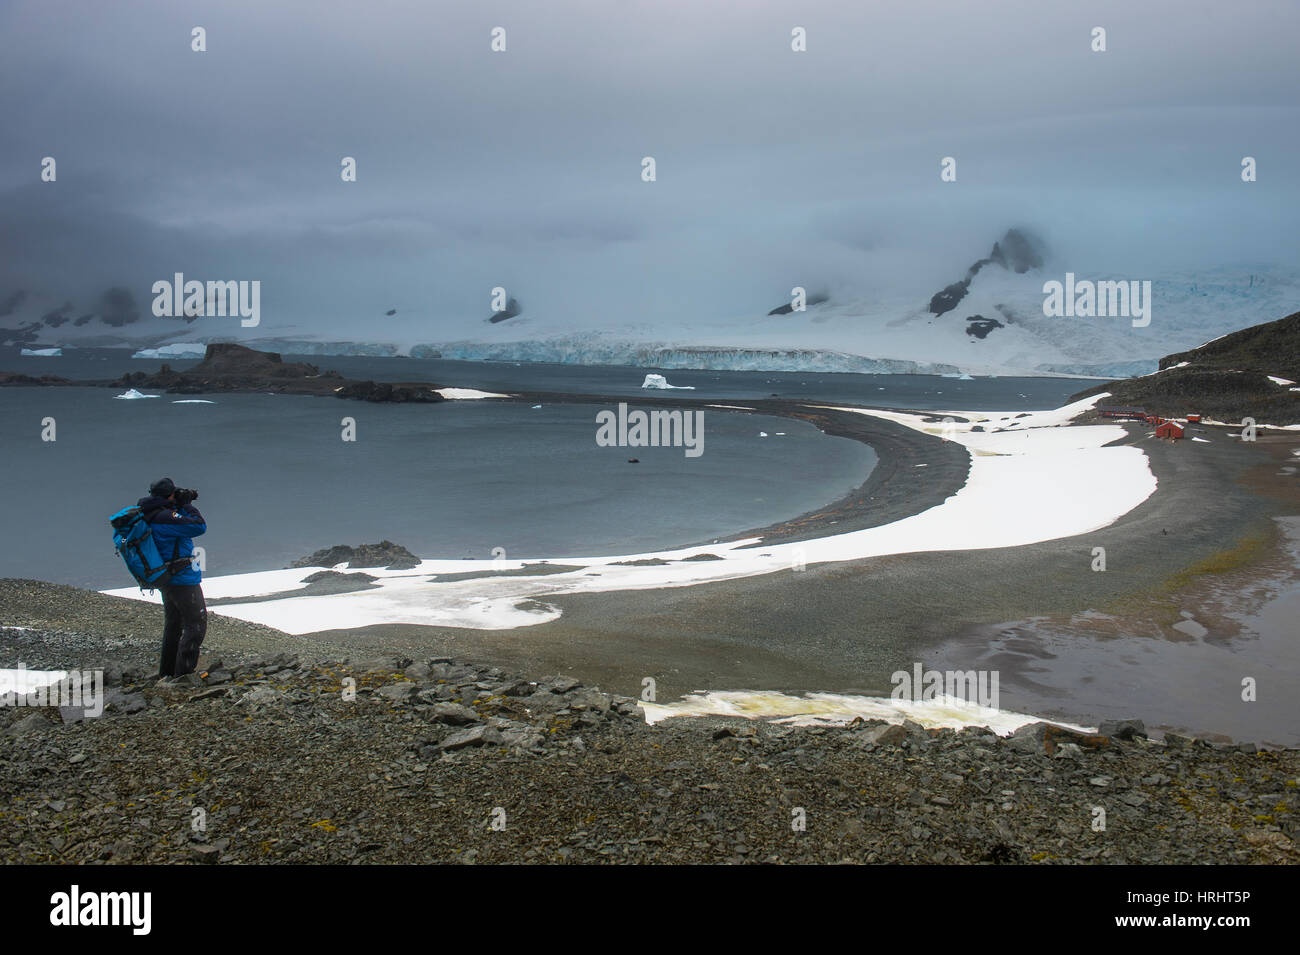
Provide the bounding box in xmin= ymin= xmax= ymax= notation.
xmin=137 ymin=478 xmax=208 ymax=677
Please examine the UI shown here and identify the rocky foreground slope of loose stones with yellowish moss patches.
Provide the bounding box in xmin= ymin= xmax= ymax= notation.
xmin=0 ymin=628 xmax=1300 ymax=863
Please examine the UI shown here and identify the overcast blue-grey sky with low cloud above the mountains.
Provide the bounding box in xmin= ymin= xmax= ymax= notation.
xmin=0 ymin=0 xmax=1300 ymax=338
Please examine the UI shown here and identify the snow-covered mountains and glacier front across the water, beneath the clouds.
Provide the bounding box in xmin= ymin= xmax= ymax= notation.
xmin=0 ymin=230 xmax=1300 ymax=377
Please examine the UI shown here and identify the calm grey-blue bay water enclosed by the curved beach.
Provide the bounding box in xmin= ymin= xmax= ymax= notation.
xmin=0 ymin=387 xmax=875 ymax=589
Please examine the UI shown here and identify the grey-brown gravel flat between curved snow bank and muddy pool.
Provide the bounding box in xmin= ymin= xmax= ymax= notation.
xmin=178 ymin=410 xmax=1297 ymax=739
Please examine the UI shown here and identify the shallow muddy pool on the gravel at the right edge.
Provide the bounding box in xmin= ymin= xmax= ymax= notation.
xmin=931 ymin=517 xmax=1300 ymax=747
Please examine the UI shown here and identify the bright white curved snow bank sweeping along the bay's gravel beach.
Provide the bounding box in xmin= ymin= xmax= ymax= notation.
xmin=105 ymin=394 xmax=1156 ymax=634
